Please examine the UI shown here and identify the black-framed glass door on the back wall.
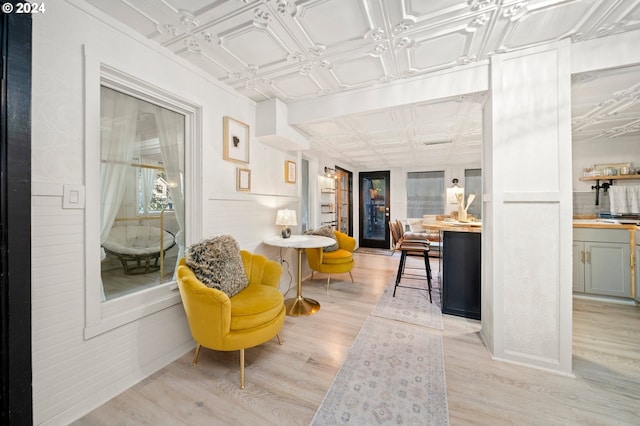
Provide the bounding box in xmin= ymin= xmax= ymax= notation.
xmin=359 ymin=171 xmax=391 ymax=248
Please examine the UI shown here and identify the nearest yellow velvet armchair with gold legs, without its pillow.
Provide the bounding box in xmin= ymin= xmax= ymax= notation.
xmin=178 ymin=250 xmax=285 ymax=389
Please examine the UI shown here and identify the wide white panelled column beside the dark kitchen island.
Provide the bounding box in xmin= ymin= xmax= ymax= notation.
xmin=481 ymin=41 xmax=572 ymax=374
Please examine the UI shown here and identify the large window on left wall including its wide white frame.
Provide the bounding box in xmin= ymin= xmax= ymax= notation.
xmin=84 ymin=57 xmax=202 ymax=339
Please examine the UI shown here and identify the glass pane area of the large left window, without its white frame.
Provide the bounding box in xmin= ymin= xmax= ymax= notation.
xmin=100 ymin=86 xmax=185 ymax=300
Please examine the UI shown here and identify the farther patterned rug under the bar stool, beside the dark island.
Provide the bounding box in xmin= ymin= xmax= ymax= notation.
xmin=371 ymin=278 xmax=443 ymax=330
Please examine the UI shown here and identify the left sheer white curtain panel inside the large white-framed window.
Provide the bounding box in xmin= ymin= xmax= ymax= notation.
xmin=100 ymin=87 xmax=138 ymax=300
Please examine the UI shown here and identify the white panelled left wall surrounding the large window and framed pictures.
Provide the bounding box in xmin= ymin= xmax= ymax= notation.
xmin=32 ymin=2 xmax=300 ymax=424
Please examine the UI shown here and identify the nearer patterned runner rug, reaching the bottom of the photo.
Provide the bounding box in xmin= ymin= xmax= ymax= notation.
xmin=311 ymin=317 xmax=449 ymax=426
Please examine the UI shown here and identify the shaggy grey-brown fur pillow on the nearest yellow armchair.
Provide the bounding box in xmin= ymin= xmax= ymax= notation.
xmin=185 ymin=235 xmax=249 ymax=297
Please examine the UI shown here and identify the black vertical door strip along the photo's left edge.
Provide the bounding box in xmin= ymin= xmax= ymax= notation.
xmin=0 ymin=7 xmax=33 ymax=425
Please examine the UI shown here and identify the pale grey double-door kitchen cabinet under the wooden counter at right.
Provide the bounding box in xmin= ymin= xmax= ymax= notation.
xmin=573 ymin=228 xmax=631 ymax=298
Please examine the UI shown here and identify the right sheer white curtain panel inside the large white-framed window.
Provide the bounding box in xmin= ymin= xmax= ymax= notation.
xmin=155 ymin=106 xmax=185 ymax=270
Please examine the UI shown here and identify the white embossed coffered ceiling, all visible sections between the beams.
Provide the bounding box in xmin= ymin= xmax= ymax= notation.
xmin=87 ymin=0 xmax=640 ymax=168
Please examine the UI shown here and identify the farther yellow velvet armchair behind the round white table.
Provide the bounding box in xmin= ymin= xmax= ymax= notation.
xmin=305 ymin=229 xmax=356 ymax=290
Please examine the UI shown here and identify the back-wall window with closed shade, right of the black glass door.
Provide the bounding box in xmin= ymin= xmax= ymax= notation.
xmin=407 ymin=171 xmax=445 ymax=218
